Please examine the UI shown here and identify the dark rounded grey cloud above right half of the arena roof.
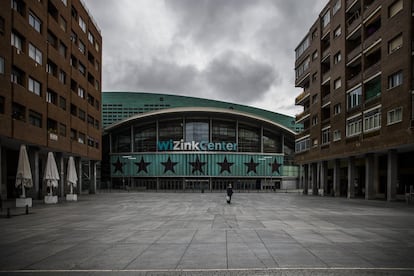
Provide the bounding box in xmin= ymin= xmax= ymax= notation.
xmin=204 ymin=51 xmax=277 ymax=103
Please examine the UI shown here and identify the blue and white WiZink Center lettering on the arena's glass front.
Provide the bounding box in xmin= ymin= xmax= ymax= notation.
xmin=157 ymin=139 xmax=237 ymax=151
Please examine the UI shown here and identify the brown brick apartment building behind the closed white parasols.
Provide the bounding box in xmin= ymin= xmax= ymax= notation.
xmin=0 ymin=0 xmax=102 ymax=199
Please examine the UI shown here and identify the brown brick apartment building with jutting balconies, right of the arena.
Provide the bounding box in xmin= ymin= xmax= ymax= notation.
xmin=295 ymin=0 xmax=414 ymax=200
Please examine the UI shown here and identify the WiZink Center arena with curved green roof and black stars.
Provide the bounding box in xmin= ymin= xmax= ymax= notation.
xmin=102 ymin=92 xmax=300 ymax=192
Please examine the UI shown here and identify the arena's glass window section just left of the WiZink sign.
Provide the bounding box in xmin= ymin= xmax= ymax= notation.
xmin=134 ymin=123 xmax=157 ymax=152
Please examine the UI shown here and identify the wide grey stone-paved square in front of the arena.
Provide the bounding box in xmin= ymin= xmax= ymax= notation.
xmin=0 ymin=193 xmax=414 ymax=275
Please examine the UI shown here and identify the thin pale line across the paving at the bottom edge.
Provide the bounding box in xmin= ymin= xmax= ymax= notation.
xmin=0 ymin=267 xmax=414 ymax=273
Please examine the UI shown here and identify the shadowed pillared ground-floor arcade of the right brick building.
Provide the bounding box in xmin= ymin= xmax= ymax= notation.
xmin=299 ymin=150 xmax=414 ymax=201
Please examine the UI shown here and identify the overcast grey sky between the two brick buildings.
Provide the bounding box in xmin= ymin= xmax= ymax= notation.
xmin=84 ymin=0 xmax=327 ymax=115
